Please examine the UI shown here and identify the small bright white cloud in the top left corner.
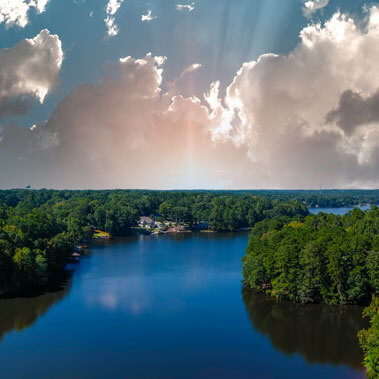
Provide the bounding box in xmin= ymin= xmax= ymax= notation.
xmin=0 ymin=0 xmax=49 ymax=28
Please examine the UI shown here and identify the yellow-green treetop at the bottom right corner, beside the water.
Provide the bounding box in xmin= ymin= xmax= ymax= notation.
xmin=358 ymin=296 xmax=379 ymax=378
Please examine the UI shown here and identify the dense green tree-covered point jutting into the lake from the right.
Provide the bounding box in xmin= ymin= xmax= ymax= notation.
xmin=243 ymin=206 xmax=379 ymax=304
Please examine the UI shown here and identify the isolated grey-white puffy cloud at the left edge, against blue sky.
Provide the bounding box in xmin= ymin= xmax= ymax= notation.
xmin=0 ymin=29 xmax=63 ymax=117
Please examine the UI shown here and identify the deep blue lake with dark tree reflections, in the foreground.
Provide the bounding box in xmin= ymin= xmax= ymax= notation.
xmin=0 ymin=233 xmax=366 ymax=379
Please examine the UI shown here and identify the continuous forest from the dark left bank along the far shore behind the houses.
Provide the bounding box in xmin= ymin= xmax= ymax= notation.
xmin=0 ymin=190 xmax=308 ymax=292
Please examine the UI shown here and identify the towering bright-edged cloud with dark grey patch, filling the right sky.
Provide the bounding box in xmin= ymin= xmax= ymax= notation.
xmin=208 ymin=7 xmax=379 ymax=187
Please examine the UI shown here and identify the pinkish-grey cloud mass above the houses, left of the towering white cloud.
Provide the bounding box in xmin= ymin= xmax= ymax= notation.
xmin=0 ymin=54 xmax=248 ymax=188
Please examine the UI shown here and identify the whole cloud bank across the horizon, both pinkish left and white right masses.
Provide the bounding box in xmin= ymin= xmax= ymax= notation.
xmin=0 ymin=7 xmax=379 ymax=188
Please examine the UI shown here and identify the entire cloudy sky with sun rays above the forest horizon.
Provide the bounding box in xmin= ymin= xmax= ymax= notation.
xmin=0 ymin=0 xmax=379 ymax=189
